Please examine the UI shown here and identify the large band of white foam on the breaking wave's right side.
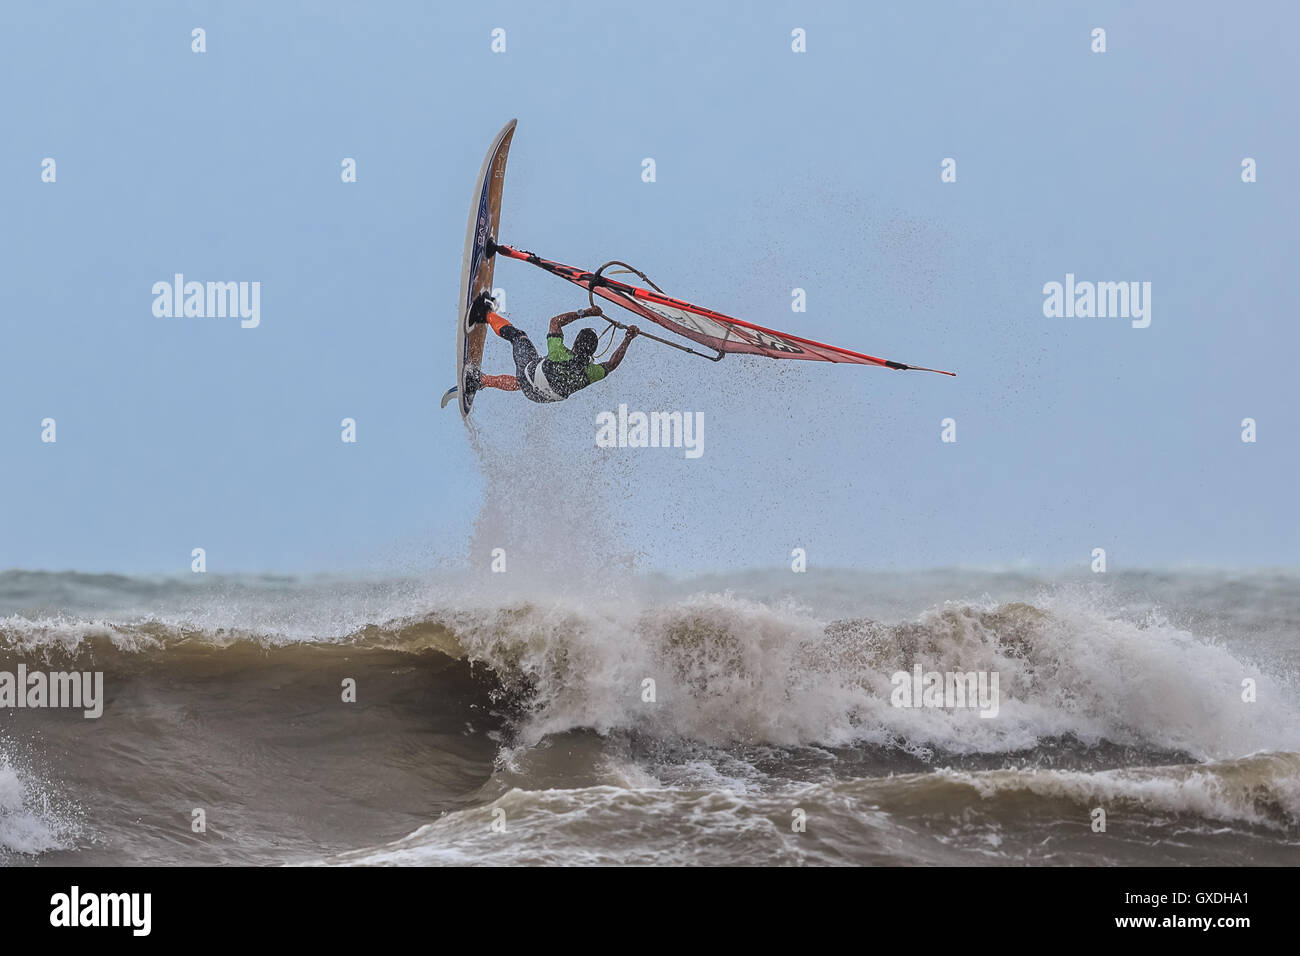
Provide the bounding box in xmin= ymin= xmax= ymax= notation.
xmin=436 ymin=582 xmax=1300 ymax=760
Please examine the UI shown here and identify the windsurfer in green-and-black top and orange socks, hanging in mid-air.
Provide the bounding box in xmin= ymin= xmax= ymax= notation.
xmin=469 ymin=291 xmax=641 ymax=402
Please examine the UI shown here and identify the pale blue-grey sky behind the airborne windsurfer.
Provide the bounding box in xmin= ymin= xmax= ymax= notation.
xmin=0 ymin=0 xmax=1300 ymax=572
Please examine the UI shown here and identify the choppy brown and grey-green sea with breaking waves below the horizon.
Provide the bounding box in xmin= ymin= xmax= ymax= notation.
xmin=0 ymin=568 xmax=1300 ymax=866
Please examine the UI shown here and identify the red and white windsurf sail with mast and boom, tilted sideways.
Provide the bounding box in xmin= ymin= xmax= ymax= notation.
xmin=489 ymin=243 xmax=957 ymax=376
